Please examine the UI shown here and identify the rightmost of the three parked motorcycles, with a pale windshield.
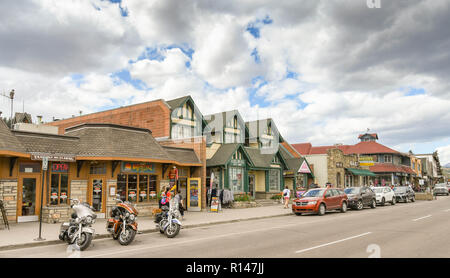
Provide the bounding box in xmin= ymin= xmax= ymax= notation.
xmin=155 ymin=200 xmax=181 ymax=238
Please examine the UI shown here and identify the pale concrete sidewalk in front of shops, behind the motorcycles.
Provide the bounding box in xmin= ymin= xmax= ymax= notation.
xmin=0 ymin=204 xmax=292 ymax=250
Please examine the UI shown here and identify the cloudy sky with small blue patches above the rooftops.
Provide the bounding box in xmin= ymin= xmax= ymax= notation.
xmin=0 ymin=0 xmax=450 ymax=165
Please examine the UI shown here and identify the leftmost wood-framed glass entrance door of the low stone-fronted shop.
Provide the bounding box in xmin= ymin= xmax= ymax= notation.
xmin=17 ymin=176 xmax=41 ymax=222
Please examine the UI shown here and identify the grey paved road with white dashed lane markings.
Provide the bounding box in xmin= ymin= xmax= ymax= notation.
xmin=0 ymin=196 xmax=450 ymax=258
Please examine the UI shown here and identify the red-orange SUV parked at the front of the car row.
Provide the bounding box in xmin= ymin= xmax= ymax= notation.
xmin=292 ymin=188 xmax=348 ymax=215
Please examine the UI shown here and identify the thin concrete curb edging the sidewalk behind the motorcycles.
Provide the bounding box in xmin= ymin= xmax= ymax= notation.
xmin=0 ymin=212 xmax=292 ymax=251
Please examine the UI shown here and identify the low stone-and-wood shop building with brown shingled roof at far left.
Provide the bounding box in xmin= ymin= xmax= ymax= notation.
xmin=0 ymin=121 xmax=203 ymax=223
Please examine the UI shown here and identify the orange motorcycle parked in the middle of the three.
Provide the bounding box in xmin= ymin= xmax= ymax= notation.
xmin=106 ymin=196 xmax=138 ymax=245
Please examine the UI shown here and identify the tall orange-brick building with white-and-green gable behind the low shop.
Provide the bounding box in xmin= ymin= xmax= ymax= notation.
xmin=48 ymin=96 xmax=207 ymax=208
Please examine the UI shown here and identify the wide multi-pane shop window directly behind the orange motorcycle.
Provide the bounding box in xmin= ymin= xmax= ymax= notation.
xmin=117 ymin=174 xmax=156 ymax=203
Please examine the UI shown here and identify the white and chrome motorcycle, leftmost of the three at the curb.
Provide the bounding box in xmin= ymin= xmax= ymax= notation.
xmin=59 ymin=199 xmax=97 ymax=251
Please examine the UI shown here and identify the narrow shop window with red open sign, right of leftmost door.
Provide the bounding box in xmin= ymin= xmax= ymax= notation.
xmin=49 ymin=163 xmax=69 ymax=205
